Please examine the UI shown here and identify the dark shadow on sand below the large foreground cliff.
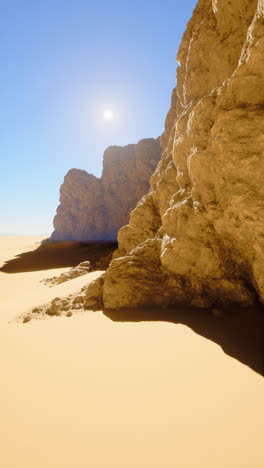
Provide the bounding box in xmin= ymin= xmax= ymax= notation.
xmin=104 ymin=306 xmax=264 ymax=376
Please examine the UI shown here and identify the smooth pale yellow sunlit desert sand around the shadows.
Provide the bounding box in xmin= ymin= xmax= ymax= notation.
xmin=0 ymin=236 xmax=264 ymax=468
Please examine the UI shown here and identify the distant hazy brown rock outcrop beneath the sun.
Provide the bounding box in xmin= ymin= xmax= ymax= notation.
xmin=50 ymin=138 xmax=161 ymax=241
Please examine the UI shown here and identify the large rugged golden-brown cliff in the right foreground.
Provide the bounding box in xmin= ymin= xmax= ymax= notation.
xmin=91 ymin=0 xmax=264 ymax=308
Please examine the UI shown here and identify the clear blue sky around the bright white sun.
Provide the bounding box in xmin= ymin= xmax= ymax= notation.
xmin=0 ymin=0 xmax=196 ymax=234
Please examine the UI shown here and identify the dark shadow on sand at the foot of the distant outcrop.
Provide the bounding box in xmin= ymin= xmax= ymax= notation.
xmin=0 ymin=241 xmax=117 ymax=273
